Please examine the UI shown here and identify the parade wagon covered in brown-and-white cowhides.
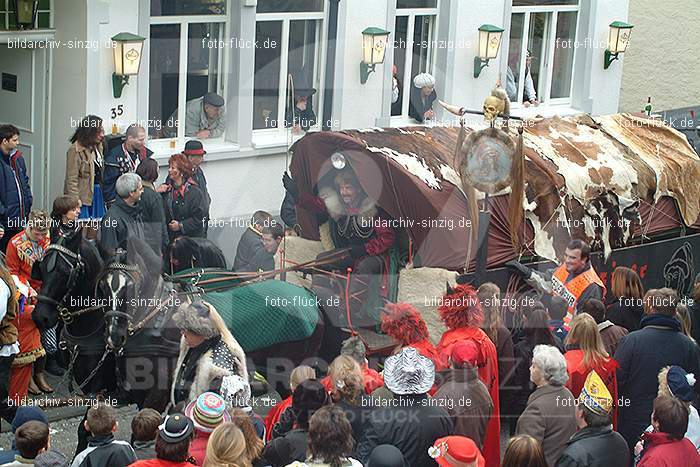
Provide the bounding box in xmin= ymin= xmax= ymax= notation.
xmin=278 ymin=114 xmax=700 ymax=339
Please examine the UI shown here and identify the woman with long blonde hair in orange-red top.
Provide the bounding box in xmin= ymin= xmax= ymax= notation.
xmin=564 ymin=313 xmax=619 ymax=427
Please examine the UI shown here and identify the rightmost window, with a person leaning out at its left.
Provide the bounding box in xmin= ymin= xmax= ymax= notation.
xmin=505 ymin=0 xmax=578 ymax=106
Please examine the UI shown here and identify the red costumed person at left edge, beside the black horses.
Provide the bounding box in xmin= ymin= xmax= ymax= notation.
xmin=6 ymin=229 xmax=50 ymax=401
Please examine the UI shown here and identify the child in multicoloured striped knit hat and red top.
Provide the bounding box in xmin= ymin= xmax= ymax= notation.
xmin=185 ymin=392 xmax=231 ymax=465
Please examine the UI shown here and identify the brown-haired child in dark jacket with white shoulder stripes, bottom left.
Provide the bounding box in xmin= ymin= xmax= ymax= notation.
xmin=71 ymin=402 xmax=136 ymax=467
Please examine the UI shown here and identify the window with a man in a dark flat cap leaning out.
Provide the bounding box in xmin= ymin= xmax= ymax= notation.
xmin=148 ymin=0 xmax=226 ymax=141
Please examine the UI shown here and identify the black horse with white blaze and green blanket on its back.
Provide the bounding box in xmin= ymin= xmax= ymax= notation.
xmin=98 ymin=239 xmax=324 ymax=395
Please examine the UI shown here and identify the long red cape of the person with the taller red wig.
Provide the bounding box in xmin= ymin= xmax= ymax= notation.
xmin=437 ymin=327 xmax=501 ymax=467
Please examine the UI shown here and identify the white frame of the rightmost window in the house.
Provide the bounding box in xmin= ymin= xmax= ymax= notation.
xmin=502 ymin=0 xmax=581 ymax=109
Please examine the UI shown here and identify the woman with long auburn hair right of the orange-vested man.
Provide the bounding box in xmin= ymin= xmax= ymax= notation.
xmin=606 ymin=266 xmax=644 ymax=332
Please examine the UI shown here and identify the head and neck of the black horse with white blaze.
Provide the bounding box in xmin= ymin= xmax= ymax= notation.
xmin=96 ymin=238 xmax=164 ymax=354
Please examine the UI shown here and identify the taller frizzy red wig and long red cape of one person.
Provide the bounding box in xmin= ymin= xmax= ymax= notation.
xmin=437 ymin=285 xmax=501 ymax=467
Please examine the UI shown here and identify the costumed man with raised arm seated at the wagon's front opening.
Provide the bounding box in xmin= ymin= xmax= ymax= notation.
xmin=282 ymin=169 xmax=396 ymax=328
